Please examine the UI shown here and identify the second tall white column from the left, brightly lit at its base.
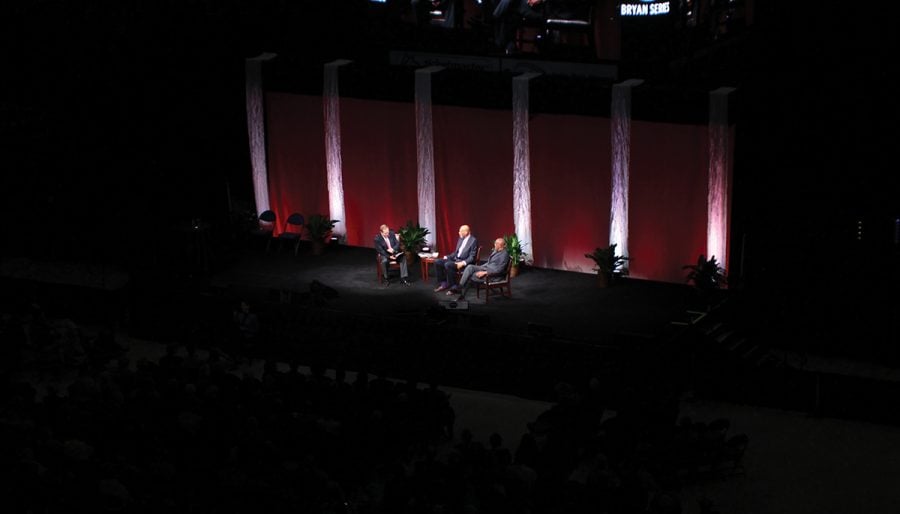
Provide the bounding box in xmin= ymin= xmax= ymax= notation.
xmin=322 ymin=59 xmax=351 ymax=242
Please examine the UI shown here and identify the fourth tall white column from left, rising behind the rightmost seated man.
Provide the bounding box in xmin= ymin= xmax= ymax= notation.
xmin=512 ymin=73 xmax=540 ymax=264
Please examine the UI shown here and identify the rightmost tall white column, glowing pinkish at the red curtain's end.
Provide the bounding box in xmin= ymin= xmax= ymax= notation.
xmin=706 ymin=87 xmax=735 ymax=268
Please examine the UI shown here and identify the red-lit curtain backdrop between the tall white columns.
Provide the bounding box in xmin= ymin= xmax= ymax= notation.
xmin=266 ymin=93 xmax=733 ymax=283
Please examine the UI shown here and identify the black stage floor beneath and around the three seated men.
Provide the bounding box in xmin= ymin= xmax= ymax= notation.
xmin=209 ymin=239 xmax=704 ymax=344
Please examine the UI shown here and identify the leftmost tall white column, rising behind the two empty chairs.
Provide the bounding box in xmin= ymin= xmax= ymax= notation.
xmin=244 ymin=53 xmax=276 ymax=216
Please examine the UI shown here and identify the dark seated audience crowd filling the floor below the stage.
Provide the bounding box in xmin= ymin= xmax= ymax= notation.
xmin=0 ymin=280 xmax=760 ymax=513
